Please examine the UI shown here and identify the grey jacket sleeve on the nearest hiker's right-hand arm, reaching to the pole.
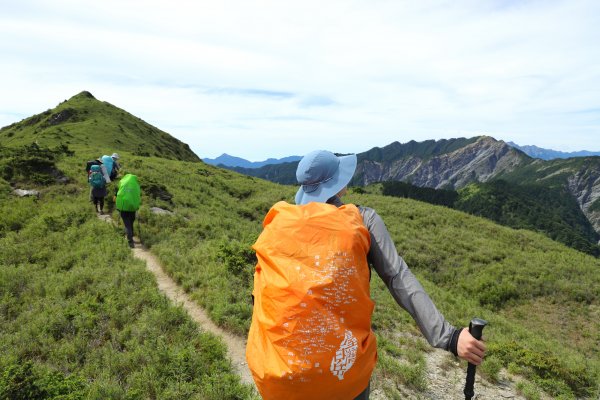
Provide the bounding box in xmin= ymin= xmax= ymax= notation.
xmin=360 ymin=207 xmax=460 ymax=354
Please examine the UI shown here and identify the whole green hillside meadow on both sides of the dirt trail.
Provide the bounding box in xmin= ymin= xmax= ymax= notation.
xmin=0 ymin=148 xmax=600 ymax=399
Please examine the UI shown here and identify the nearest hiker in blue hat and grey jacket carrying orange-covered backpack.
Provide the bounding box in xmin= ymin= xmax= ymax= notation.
xmin=246 ymin=150 xmax=485 ymax=400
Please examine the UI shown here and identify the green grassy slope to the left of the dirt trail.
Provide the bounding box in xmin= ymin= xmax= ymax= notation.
xmin=0 ymin=159 xmax=253 ymax=399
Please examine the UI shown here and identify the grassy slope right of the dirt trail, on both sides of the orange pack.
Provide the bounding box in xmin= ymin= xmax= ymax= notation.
xmin=104 ymin=152 xmax=600 ymax=398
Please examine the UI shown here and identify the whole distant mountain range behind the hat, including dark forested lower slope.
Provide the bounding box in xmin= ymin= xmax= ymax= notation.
xmin=223 ymin=136 xmax=600 ymax=252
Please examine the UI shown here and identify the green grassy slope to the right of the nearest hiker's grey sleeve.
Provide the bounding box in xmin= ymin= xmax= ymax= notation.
xmin=355 ymin=195 xmax=600 ymax=396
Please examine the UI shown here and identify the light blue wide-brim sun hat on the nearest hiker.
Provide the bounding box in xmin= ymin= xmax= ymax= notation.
xmin=296 ymin=150 xmax=356 ymax=205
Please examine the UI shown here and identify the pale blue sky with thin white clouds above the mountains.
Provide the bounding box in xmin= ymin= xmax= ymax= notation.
xmin=0 ymin=0 xmax=600 ymax=161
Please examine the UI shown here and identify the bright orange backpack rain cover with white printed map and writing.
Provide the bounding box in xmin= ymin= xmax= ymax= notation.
xmin=246 ymin=201 xmax=377 ymax=400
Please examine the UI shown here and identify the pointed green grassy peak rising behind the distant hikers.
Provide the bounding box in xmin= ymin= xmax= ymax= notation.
xmin=0 ymin=92 xmax=199 ymax=161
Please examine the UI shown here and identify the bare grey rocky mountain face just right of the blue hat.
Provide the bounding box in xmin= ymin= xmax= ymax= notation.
xmin=353 ymin=136 xmax=531 ymax=189
